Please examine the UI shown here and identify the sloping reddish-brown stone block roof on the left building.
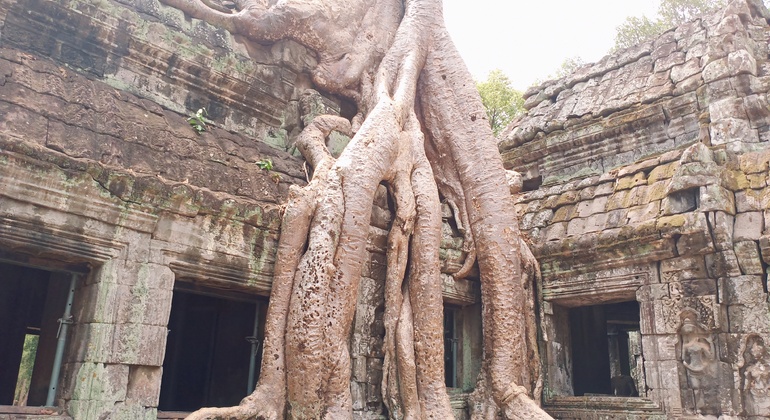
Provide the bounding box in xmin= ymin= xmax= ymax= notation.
xmin=0 ymin=49 xmax=304 ymax=201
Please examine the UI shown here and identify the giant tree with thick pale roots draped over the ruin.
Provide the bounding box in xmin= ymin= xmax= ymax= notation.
xmin=164 ymin=0 xmax=547 ymax=419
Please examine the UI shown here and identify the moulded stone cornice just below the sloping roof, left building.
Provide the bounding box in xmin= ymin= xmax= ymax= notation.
xmin=0 ymin=139 xmax=281 ymax=232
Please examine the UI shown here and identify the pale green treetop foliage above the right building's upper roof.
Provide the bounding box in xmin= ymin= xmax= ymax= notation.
xmin=613 ymin=0 xmax=726 ymax=51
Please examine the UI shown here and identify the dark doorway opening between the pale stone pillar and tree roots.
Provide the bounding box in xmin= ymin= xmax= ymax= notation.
xmin=158 ymin=290 xmax=267 ymax=411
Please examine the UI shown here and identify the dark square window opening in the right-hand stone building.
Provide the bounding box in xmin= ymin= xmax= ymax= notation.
xmin=569 ymin=301 xmax=643 ymax=397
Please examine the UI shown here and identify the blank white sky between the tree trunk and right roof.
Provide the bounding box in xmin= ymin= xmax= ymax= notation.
xmin=444 ymin=0 xmax=658 ymax=91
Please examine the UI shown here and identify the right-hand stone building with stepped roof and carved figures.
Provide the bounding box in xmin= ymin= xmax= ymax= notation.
xmin=500 ymin=1 xmax=770 ymax=419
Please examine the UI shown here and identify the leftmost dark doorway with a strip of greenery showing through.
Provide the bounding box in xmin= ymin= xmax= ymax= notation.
xmin=0 ymin=263 xmax=71 ymax=406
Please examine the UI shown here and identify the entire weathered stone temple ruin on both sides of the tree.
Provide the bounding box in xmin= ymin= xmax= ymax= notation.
xmin=0 ymin=0 xmax=770 ymax=419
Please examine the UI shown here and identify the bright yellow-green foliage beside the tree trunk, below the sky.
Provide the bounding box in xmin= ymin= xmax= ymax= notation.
xmin=476 ymin=70 xmax=524 ymax=136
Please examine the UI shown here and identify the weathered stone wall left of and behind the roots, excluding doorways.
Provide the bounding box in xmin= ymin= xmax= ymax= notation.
xmin=0 ymin=0 xmax=481 ymax=419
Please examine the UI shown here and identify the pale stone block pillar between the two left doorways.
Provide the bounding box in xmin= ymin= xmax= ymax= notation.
xmin=60 ymin=253 xmax=174 ymax=419
